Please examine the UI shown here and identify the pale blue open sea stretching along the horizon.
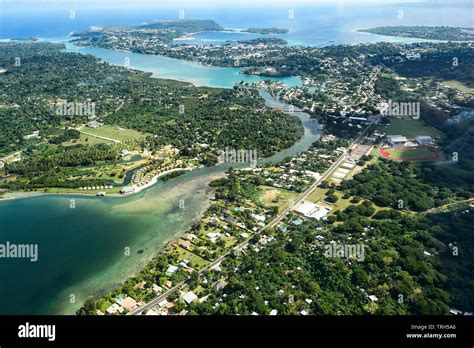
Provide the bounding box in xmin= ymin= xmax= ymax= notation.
xmin=0 ymin=0 xmax=474 ymax=46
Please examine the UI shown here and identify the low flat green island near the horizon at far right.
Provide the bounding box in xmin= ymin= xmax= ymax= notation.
xmin=358 ymin=26 xmax=474 ymax=41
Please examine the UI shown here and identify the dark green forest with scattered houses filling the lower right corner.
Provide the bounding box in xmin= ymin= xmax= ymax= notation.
xmin=187 ymin=169 xmax=474 ymax=315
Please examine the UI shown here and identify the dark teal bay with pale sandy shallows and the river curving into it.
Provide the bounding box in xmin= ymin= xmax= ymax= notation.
xmin=0 ymin=41 xmax=319 ymax=314
